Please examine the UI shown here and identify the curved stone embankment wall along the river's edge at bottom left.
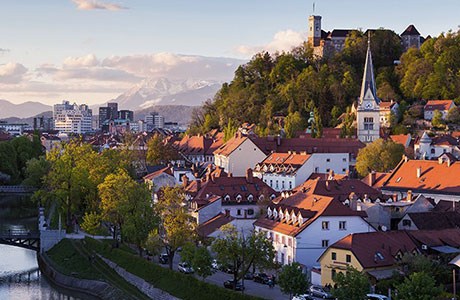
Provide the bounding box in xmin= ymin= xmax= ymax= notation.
xmin=38 ymin=254 xmax=125 ymax=300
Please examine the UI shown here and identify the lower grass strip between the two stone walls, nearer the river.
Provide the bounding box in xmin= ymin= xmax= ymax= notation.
xmin=48 ymin=239 xmax=149 ymax=299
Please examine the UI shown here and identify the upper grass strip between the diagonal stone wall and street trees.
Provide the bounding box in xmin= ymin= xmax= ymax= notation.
xmin=85 ymin=238 xmax=259 ymax=300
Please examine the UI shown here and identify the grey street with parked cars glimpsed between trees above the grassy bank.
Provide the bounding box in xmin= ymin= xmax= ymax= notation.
xmin=154 ymin=254 xmax=326 ymax=300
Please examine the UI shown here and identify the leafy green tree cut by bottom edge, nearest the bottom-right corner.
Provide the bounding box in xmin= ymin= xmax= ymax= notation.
xmin=397 ymin=272 xmax=442 ymax=300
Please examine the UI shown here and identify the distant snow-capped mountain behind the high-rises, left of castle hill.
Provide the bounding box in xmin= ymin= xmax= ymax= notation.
xmin=112 ymin=77 xmax=221 ymax=110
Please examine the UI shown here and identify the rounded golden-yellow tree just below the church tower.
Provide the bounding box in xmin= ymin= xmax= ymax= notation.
xmin=356 ymin=139 xmax=404 ymax=177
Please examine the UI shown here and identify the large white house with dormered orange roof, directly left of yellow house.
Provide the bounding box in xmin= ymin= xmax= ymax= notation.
xmin=254 ymin=188 xmax=375 ymax=268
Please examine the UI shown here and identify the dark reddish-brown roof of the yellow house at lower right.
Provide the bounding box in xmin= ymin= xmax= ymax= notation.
xmin=326 ymin=231 xmax=417 ymax=269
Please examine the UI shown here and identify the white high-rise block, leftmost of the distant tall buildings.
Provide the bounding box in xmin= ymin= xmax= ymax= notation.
xmin=53 ymin=100 xmax=93 ymax=134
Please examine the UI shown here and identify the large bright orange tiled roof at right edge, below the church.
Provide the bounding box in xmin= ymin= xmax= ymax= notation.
xmin=382 ymin=160 xmax=460 ymax=194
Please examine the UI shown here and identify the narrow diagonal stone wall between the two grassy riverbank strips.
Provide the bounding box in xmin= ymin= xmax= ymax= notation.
xmin=99 ymin=255 xmax=179 ymax=300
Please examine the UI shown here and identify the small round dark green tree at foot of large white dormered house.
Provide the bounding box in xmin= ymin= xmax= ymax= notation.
xmin=278 ymin=262 xmax=308 ymax=299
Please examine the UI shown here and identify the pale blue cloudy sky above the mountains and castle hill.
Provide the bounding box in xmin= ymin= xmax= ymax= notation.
xmin=0 ymin=0 xmax=460 ymax=109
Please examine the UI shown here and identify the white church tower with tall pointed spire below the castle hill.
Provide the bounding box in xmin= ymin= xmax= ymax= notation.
xmin=356 ymin=38 xmax=380 ymax=143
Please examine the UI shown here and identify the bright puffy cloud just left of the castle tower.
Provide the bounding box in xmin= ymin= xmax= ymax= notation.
xmin=236 ymin=29 xmax=306 ymax=56
